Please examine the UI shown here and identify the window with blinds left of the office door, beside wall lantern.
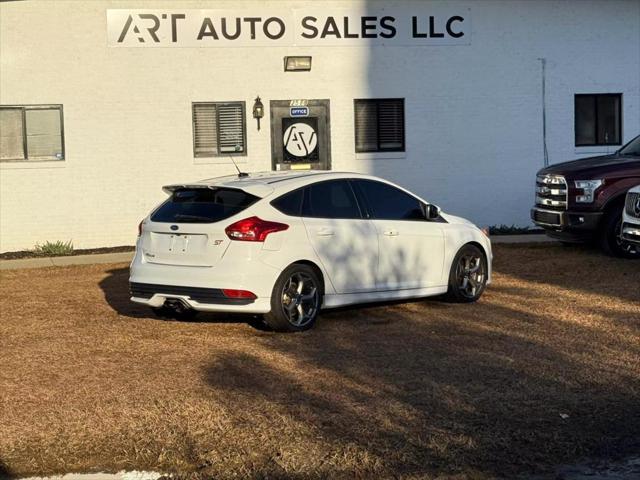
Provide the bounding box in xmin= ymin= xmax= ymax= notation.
xmin=193 ymin=102 xmax=247 ymax=157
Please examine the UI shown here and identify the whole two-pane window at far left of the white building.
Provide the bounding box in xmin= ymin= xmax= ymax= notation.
xmin=0 ymin=105 xmax=64 ymax=162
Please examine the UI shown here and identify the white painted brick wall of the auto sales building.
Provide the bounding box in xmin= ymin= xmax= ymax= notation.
xmin=0 ymin=0 xmax=640 ymax=251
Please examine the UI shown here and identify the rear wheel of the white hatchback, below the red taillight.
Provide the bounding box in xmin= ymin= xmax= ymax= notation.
xmin=264 ymin=263 xmax=324 ymax=332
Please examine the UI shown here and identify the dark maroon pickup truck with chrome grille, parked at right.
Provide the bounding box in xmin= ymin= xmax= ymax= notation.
xmin=531 ymin=136 xmax=640 ymax=258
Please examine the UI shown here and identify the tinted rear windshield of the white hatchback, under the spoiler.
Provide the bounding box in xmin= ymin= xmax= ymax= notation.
xmin=151 ymin=188 xmax=259 ymax=223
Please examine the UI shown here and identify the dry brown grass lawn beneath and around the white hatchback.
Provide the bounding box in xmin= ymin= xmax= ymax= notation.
xmin=0 ymin=246 xmax=640 ymax=478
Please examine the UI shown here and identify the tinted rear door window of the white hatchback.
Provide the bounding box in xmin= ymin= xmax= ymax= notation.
xmin=302 ymin=180 xmax=362 ymax=218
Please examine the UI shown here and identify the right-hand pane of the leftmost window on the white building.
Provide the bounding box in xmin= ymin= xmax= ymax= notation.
xmin=25 ymin=109 xmax=63 ymax=160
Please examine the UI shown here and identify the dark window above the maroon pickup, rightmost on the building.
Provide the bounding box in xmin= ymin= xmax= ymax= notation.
xmin=575 ymin=93 xmax=622 ymax=147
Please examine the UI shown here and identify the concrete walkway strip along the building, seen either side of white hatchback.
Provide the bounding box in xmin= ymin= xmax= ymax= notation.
xmin=0 ymin=235 xmax=556 ymax=270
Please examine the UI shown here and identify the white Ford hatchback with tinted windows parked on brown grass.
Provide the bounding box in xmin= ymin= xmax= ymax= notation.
xmin=130 ymin=171 xmax=492 ymax=331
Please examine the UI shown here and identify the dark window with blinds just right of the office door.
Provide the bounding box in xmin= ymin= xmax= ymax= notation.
xmin=354 ymin=98 xmax=404 ymax=152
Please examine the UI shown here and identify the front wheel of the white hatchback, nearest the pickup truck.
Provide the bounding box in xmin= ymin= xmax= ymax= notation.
xmin=445 ymin=243 xmax=488 ymax=303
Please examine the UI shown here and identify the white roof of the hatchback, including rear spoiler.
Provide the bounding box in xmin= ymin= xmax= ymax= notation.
xmin=163 ymin=170 xmax=375 ymax=197
